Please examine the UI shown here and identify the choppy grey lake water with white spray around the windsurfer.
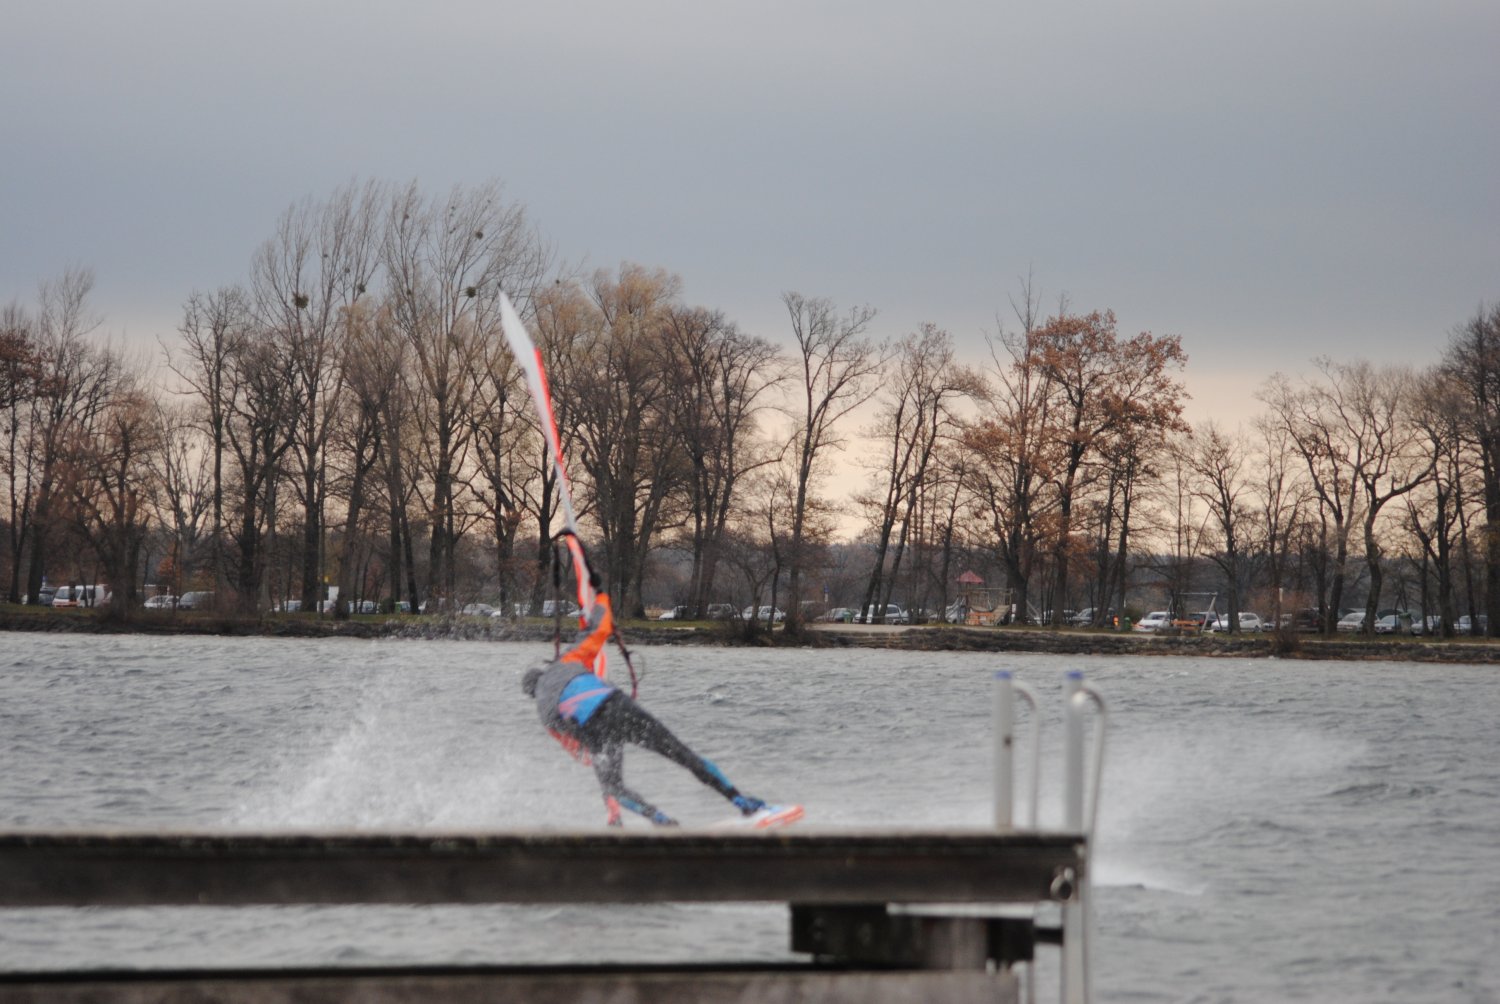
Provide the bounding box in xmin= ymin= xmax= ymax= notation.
xmin=0 ymin=633 xmax=1500 ymax=1001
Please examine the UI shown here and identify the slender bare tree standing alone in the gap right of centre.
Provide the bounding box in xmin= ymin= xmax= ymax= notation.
xmin=782 ymin=293 xmax=887 ymax=632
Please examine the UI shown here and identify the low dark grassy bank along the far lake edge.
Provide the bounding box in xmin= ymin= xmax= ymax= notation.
xmin=0 ymin=606 xmax=1500 ymax=665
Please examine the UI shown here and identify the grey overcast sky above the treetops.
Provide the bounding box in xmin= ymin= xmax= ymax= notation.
xmin=0 ymin=0 xmax=1500 ymax=423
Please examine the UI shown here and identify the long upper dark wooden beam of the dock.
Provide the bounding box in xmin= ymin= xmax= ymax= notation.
xmin=0 ymin=830 xmax=1086 ymax=906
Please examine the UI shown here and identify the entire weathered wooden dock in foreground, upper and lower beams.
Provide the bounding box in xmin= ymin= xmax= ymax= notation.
xmin=0 ymin=830 xmax=1088 ymax=1004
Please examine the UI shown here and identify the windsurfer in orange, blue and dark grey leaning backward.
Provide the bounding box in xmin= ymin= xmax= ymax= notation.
xmin=522 ymin=596 xmax=764 ymax=825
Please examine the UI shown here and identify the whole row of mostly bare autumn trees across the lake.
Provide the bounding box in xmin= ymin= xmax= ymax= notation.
xmin=0 ymin=182 xmax=1500 ymax=632
